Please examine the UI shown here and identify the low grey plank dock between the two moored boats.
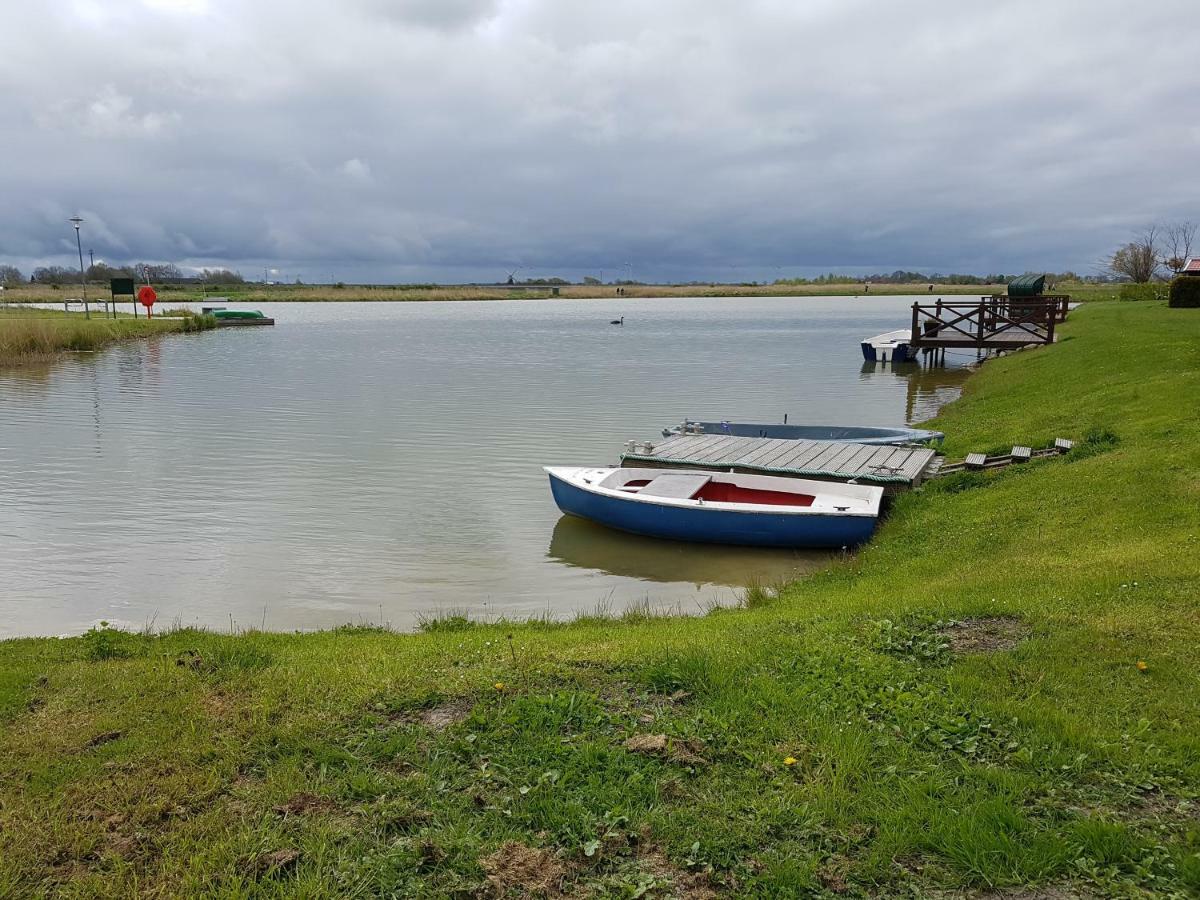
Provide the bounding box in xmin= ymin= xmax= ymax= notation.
xmin=620 ymin=434 xmax=942 ymax=492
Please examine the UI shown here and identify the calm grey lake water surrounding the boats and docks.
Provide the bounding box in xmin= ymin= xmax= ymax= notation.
xmin=0 ymin=298 xmax=965 ymax=636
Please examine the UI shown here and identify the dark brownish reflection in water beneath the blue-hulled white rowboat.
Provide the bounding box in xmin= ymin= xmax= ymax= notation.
xmin=546 ymin=516 xmax=829 ymax=588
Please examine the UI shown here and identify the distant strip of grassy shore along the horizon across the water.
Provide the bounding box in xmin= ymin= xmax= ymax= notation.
xmin=5 ymin=282 xmax=1120 ymax=304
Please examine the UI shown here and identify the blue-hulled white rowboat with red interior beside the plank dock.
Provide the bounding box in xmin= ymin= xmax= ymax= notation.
xmin=545 ymin=466 xmax=883 ymax=547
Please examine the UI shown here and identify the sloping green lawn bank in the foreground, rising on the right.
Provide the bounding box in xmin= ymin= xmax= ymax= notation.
xmin=0 ymin=304 xmax=1200 ymax=898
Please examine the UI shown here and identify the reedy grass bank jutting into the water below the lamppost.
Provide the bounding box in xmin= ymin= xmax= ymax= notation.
xmin=0 ymin=307 xmax=216 ymax=368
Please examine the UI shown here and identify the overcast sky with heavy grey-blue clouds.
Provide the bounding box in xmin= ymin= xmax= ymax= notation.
xmin=0 ymin=0 xmax=1200 ymax=281
